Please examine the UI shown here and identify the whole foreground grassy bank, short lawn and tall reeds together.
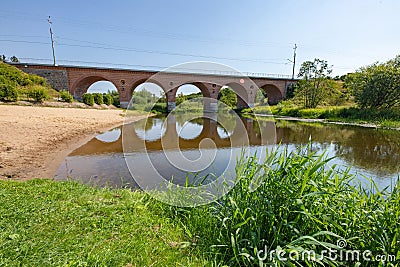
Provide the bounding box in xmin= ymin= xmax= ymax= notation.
xmin=0 ymin=148 xmax=400 ymax=266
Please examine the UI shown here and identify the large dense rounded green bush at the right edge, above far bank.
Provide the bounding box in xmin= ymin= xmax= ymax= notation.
xmin=345 ymin=55 xmax=400 ymax=109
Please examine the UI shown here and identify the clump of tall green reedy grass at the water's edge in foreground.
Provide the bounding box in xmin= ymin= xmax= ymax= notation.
xmin=157 ymin=149 xmax=400 ymax=266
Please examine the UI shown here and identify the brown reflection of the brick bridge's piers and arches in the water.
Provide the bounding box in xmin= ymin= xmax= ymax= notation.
xmin=71 ymin=115 xmax=281 ymax=156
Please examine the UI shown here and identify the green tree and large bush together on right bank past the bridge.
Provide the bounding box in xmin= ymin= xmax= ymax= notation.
xmin=294 ymin=55 xmax=400 ymax=109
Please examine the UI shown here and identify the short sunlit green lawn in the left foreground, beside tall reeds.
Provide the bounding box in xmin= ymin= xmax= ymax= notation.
xmin=0 ymin=180 xmax=204 ymax=266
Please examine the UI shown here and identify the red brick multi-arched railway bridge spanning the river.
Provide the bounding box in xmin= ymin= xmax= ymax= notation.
xmin=13 ymin=63 xmax=296 ymax=112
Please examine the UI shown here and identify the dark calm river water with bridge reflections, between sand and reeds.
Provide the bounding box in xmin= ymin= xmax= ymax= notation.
xmin=55 ymin=114 xmax=400 ymax=192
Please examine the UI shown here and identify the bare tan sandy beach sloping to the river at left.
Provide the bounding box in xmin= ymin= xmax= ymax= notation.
xmin=0 ymin=105 xmax=146 ymax=180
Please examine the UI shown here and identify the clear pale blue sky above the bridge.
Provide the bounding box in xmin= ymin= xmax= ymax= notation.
xmin=0 ymin=0 xmax=400 ymax=93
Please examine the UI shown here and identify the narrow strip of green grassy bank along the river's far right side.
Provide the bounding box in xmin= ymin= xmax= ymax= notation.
xmin=242 ymin=105 xmax=400 ymax=128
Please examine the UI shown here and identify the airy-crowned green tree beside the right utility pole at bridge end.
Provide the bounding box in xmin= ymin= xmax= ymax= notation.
xmin=297 ymin=58 xmax=332 ymax=108
